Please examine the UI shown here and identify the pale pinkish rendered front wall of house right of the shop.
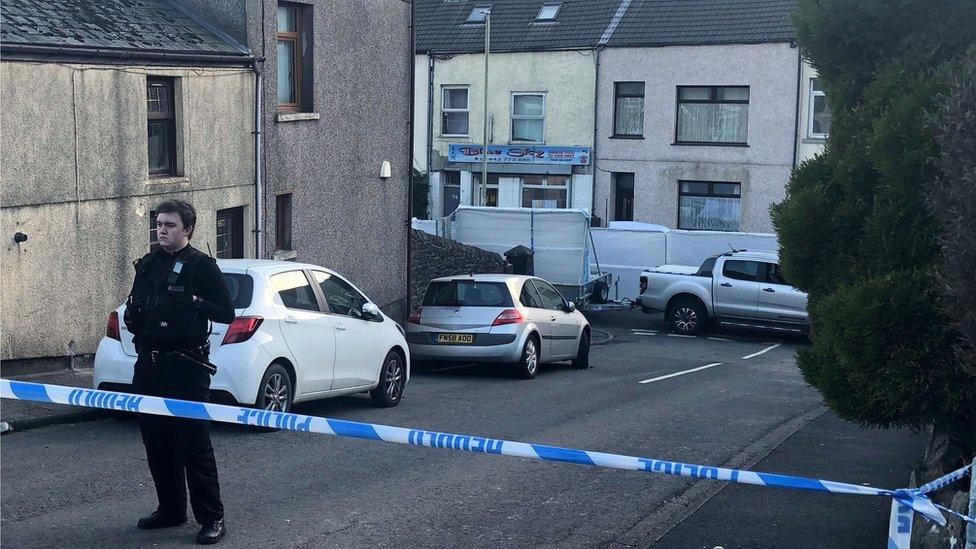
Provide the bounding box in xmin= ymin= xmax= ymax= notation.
xmin=594 ymin=43 xmax=799 ymax=232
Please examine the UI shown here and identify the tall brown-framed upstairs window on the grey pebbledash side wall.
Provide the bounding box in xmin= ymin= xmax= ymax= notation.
xmin=277 ymin=2 xmax=313 ymax=112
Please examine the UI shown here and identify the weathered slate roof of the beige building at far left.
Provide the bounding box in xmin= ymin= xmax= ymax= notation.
xmin=0 ymin=0 xmax=250 ymax=62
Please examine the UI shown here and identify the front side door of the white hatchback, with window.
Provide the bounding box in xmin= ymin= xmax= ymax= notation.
xmin=312 ymin=271 xmax=384 ymax=389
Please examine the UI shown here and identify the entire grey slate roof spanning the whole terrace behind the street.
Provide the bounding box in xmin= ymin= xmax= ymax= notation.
xmin=415 ymin=0 xmax=794 ymax=53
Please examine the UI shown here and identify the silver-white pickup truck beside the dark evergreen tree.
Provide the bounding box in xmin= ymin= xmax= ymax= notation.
xmin=637 ymin=250 xmax=810 ymax=334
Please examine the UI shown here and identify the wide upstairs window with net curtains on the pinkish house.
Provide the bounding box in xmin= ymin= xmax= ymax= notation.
xmin=675 ymin=86 xmax=749 ymax=145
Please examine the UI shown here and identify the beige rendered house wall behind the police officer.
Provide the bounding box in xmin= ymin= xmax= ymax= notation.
xmin=0 ymin=61 xmax=254 ymax=360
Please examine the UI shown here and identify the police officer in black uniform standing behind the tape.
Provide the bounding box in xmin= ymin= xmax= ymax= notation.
xmin=125 ymin=200 xmax=234 ymax=544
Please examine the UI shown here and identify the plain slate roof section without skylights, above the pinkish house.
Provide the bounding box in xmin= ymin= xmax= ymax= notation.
xmin=609 ymin=0 xmax=794 ymax=47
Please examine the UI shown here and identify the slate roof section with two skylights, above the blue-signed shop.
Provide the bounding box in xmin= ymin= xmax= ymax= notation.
xmin=415 ymin=0 xmax=620 ymax=53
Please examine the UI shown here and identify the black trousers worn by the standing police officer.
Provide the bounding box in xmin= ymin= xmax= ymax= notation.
xmin=133 ymin=353 xmax=224 ymax=524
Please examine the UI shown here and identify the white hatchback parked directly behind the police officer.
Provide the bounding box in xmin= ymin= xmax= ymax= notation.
xmin=94 ymin=259 xmax=410 ymax=412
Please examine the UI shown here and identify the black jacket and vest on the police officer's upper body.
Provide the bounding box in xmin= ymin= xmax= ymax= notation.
xmin=125 ymin=245 xmax=234 ymax=352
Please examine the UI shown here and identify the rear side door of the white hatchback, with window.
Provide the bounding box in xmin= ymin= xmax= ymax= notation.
xmin=271 ymin=270 xmax=336 ymax=394
